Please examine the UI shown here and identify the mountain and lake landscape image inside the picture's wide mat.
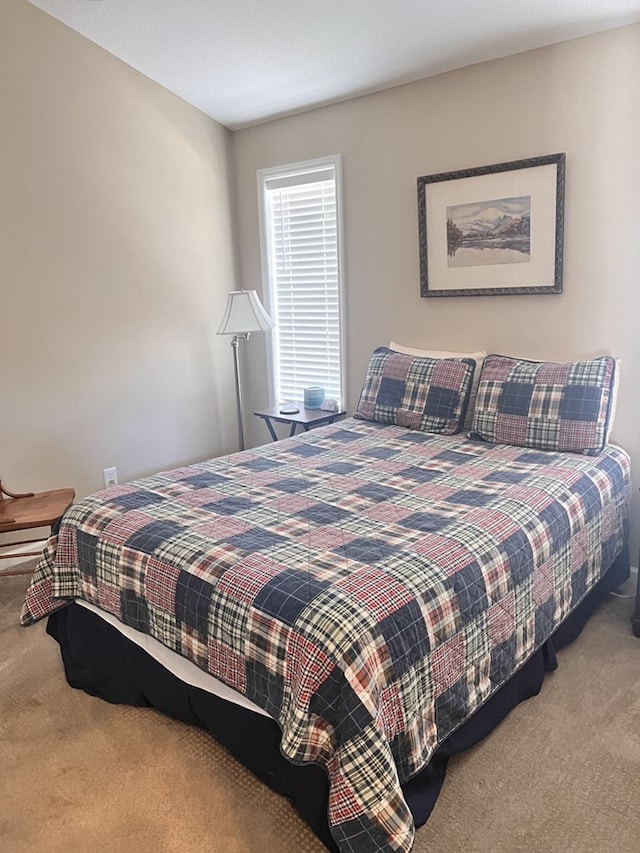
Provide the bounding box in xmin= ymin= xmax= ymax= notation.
xmin=446 ymin=195 xmax=531 ymax=267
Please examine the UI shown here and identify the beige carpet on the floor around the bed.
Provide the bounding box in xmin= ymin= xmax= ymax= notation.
xmin=0 ymin=564 xmax=640 ymax=853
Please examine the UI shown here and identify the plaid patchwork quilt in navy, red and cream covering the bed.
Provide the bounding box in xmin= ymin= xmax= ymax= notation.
xmin=22 ymin=419 xmax=630 ymax=853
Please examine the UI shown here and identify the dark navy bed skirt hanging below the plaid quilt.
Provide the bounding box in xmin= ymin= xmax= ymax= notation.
xmin=47 ymin=548 xmax=629 ymax=853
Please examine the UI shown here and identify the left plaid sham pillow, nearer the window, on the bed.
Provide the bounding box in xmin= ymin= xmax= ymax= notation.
xmin=354 ymin=347 xmax=476 ymax=435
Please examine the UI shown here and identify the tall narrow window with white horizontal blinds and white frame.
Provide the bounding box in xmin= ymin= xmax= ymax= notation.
xmin=258 ymin=157 xmax=344 ymax=410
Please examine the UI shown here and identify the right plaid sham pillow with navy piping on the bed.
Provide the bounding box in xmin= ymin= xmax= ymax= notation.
xmin=469 ymin=355 xmax=616 ymax=454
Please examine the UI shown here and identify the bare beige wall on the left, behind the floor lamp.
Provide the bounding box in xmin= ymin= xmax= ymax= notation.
xmin=0 ymin=0 xmax=236 ymax=520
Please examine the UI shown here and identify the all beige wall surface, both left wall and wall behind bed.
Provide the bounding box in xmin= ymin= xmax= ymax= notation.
xmin=0 ymin=0 xmax=640 ymax=562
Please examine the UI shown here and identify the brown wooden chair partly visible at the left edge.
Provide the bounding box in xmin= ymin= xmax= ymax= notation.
xmin=0 ymin=480 xmax=76 ymax=577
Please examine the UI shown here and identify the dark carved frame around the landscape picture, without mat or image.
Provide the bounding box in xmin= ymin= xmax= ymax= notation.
xmin=418 ymin=153 xmax=566 ymax=296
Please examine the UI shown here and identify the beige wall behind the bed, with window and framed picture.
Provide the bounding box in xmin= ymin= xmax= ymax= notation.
xmin=234 ymin=26 xmax=640 ymax=563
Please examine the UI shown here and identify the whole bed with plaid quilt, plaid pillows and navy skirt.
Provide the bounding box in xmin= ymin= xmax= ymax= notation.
xmin=22 ymin=348 xmax=630 ymax=853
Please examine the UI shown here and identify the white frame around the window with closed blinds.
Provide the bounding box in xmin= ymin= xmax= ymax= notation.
xmin=257 ymin=154 xmax=346 ymax=409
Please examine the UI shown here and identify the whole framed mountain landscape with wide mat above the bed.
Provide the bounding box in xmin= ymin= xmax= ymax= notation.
xmin=418 ymin=154 xmax=565 ymax=296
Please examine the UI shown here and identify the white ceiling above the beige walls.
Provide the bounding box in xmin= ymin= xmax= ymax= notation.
xmin=30 ymin=0 xmax=640 ymax=130
